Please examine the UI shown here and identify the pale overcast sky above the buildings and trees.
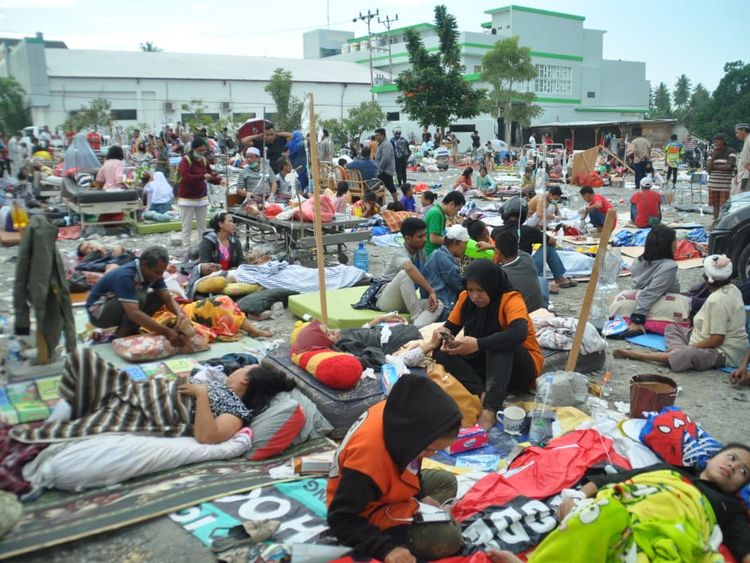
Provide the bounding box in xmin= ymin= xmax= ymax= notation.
xmin=0 ymin=0 xmax=750 ymax=91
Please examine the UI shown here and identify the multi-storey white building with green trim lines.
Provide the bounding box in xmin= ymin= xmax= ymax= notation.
xmin=306 ymin=5 xmax=649 ymax=147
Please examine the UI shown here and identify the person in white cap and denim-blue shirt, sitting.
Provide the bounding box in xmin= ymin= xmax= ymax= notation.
xmin=424 ymin=225 xmax=469 ymax=321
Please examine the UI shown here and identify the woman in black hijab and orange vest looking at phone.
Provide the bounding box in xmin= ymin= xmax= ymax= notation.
xmin=433 ymin=260 xmax=543 ymax=430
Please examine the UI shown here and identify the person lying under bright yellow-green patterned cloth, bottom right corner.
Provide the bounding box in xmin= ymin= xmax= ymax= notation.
xmin=489 ymin=444 xmax=750 ymax=563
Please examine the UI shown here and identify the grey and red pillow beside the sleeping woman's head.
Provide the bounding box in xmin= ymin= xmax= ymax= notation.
xmin=247 ymin=393 xmax=305 ymax=461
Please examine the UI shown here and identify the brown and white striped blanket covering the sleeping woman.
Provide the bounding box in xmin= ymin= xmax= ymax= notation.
xmin=11 ymin=348 xmax=192 ymax=443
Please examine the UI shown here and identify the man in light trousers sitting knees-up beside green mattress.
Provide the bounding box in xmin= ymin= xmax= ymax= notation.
xmin=376 ymin=217 xmax=444 ymax=328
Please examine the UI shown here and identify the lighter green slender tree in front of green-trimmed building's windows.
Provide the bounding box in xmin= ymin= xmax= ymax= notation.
xmin=482 ymin=36 xmax=544 ymax=142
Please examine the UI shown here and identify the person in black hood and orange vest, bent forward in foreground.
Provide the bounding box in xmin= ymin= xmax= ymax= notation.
xmin=326 ymin=374 xmax=463 ymax=563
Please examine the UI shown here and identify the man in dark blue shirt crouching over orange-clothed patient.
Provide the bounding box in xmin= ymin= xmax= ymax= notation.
xmin=86 ymin=246 xmax=185 ymax=346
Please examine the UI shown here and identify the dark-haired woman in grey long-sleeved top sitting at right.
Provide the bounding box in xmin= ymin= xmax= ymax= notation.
xmin=613 ymin=225 xmax=680 ymax=338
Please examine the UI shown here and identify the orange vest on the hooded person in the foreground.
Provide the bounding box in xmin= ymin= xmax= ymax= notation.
xmin=326 ymin=401 xmax=420 ymax=530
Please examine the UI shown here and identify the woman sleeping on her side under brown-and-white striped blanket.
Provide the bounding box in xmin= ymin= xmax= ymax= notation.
xmin=13 ymin=348 xmax=294 ymax=444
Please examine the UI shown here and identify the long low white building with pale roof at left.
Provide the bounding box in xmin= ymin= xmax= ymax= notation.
xmin=0 ymin=34 xmax=371 ymax=130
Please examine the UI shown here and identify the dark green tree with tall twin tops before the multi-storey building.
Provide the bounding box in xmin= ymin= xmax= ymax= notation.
xmin=396 ymin=5 xmax=486 ymax=128
